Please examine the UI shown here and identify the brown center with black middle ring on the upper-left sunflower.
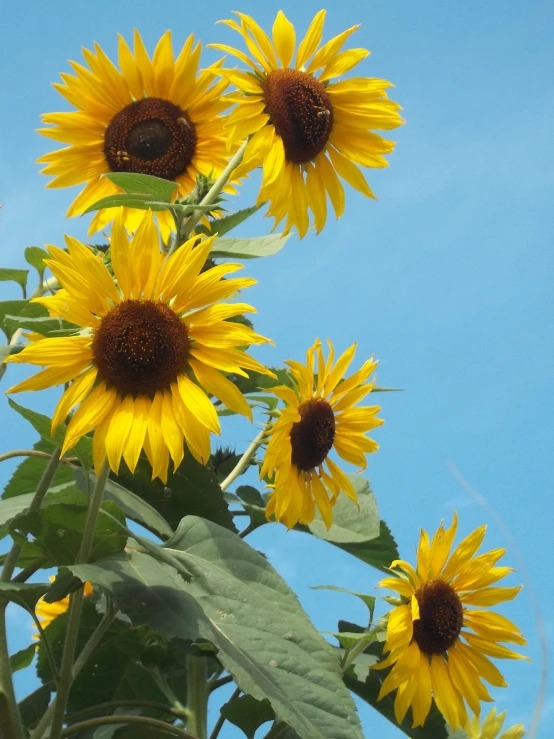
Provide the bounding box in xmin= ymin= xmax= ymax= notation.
xmin=104 ymin=98 xmax=196 ymax=180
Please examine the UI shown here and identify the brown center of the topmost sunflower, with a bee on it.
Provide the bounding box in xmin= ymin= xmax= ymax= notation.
xmin=264 ymin=69 xmax=333 ymax=164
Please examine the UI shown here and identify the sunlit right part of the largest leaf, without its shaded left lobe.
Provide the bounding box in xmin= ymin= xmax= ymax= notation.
xmin=165 ymin=516 xmax=362 ymax=739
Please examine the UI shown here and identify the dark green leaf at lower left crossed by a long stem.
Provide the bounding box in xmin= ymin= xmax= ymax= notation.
xmin=11 ymin=498 xmax=127 ymax=565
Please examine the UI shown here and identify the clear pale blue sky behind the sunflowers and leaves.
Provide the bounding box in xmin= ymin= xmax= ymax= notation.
xmin=0 ymin=0 xmax=554 ymax=739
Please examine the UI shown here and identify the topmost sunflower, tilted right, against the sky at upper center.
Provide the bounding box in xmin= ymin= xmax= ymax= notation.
xmin=210 ymin=10 xmax=403 ymax=237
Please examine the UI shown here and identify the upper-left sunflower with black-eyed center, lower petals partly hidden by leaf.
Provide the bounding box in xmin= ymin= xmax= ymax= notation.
xmin=38 ymin=30 xmax=230 ymax=239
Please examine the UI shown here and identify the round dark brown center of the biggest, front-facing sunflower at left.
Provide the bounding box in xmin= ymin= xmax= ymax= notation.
xmin=92 ymin=300 xmax=190 ymax=396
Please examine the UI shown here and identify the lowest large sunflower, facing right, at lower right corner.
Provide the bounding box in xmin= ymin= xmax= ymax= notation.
xmin=374 ymin=514 xmax=527 ymax=731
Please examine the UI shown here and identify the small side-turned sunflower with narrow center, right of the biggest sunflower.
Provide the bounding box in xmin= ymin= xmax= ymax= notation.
xmin=260 ymin=339 xmax=384 ymax=529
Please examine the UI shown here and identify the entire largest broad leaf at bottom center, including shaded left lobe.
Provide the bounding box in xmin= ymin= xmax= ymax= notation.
xmin=70 ymin=516 xmax=362 ymax=739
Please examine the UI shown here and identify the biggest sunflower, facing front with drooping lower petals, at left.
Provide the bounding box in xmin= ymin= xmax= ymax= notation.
xmin=6 ymin=211 xmax=272 ymax=482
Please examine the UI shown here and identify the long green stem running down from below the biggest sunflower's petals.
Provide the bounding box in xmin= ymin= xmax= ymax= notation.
xmin=45 ymin=462 xmax=110 ymax=739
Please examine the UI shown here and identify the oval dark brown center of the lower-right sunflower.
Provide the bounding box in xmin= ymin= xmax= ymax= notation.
xmin=414 ymin=580 xmax=463 ymax=654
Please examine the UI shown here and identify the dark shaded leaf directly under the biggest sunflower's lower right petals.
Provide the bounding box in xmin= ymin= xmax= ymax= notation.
xmin=115 ymin=453 xmax=236 ymax=531
